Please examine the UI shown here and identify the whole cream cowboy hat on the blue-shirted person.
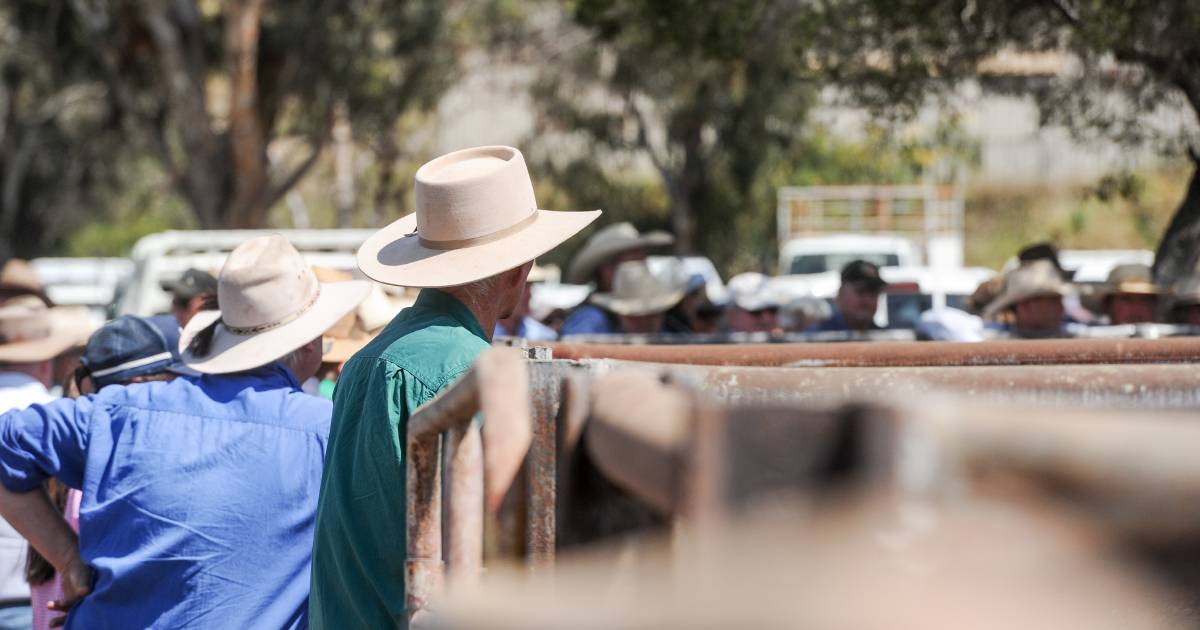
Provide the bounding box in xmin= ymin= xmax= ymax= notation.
xmin=179 ymin=234 xmax=371 ymax=374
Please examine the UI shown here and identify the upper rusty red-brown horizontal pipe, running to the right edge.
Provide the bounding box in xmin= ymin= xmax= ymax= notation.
xmin=548 ymin=337 xmax=1200 ymax=367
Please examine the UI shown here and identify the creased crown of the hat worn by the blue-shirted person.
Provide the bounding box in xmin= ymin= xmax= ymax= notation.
xmin=217 ymin=234 xmax=320 ymax=329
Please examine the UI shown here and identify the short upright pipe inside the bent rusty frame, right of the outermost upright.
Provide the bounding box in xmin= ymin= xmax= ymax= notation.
xmin=445 ymin=421 xmax=484 ymax=584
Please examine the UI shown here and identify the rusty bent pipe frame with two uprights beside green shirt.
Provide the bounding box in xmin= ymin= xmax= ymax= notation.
xmin=404 ymin=348 xmax=532 ymax=620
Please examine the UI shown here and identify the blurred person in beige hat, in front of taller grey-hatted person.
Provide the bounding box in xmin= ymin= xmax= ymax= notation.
xmin=592 ymin=260 xmax=684 ymax=335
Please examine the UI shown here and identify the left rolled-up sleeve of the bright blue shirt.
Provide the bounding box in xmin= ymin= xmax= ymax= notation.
xmin=0 ymin=396 xmax=95 ymax=492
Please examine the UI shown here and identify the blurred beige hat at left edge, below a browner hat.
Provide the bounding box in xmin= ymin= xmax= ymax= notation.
xmin=0 ymin=295 xmax=86 ymax=364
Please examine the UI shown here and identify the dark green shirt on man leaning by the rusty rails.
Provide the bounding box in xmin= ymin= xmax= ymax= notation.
xmin=308 ymin=289 xmax=488 ymax=630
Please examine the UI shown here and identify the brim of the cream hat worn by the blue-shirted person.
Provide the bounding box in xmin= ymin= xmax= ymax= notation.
xmin=179 ymin=280 xmax=371 ymax=374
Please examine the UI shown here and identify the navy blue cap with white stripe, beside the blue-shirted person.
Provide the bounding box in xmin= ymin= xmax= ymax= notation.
xmin=79 ymin=316 xmax=186 ymax=390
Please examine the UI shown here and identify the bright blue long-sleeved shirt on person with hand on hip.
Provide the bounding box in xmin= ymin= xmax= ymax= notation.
xmin=0 ymin=364 xmax=328 ymax=630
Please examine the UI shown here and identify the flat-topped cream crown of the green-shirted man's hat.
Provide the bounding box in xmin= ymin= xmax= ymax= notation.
xmin=415 ymin=146 xmax=538 ymax=242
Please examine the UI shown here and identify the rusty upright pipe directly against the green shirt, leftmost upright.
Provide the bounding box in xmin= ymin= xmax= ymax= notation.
xmin=404 ymin=436 xmax=444 ymax=620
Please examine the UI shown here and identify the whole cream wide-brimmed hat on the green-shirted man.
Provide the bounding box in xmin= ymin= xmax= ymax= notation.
xmin=358 ymin=146 xmax=600 ymax=287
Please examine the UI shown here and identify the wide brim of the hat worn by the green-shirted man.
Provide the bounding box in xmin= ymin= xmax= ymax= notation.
xmin=358 ymin=210 xmax=600 ymax=288
